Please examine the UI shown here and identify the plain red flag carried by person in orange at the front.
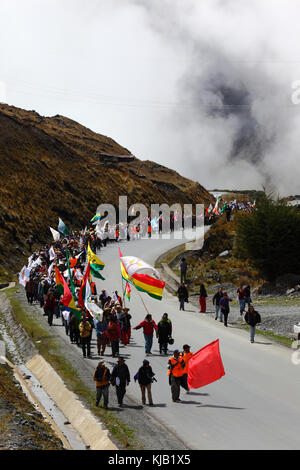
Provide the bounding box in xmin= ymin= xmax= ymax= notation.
xmin=188 ymin=339 xmax=225 ymax=388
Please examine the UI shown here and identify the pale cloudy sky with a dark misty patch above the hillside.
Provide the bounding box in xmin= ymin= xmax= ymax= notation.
xmin=0 ymin=0 xmax=300 ymax=196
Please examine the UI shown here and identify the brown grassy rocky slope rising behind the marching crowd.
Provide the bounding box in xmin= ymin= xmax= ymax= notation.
xmin=0 ymin=104 xmax=213 ymax=275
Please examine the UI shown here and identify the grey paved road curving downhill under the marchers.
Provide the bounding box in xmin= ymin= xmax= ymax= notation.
xmin=92 ymin=240 xmax=300 ymax=449
